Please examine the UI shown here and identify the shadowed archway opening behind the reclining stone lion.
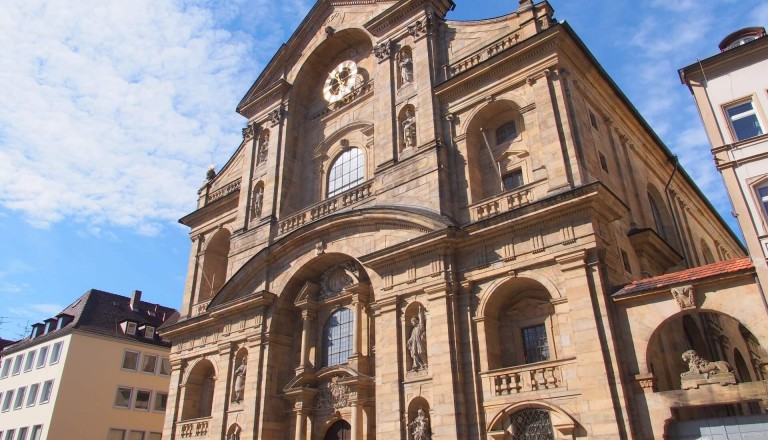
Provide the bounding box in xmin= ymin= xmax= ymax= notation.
xmin=646 ymin=310 xmax=765 ymax=391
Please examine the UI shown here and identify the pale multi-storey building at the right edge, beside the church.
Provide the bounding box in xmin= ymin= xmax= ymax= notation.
xmin=679 ymin=27 xmax=768 ymax=291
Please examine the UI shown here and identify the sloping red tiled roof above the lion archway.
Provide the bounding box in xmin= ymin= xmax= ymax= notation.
xmin=613 ymin=257 xmax=755 ymax=296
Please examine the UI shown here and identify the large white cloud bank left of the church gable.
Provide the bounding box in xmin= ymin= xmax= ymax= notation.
xmin=0 ymin=0 xmax=308 ymax=235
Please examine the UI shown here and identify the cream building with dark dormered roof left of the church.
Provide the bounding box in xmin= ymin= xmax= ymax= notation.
xmin=0 ymin=289 xmax=178 ymax=440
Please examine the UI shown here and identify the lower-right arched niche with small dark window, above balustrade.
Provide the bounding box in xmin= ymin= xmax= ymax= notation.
xmin=476 ymin=277 xmax=560 ymax=370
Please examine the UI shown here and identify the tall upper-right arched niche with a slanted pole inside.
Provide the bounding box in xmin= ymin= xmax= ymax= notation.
xmin=464 ymin=99 xmax=533 ymax=203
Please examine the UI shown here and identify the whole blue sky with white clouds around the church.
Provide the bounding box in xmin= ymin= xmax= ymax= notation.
xmin=0 ymin=0 xmax=768 ymax=339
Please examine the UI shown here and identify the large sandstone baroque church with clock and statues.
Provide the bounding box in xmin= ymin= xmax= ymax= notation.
xmin=160 ymin=0 xmax=768 ymax=440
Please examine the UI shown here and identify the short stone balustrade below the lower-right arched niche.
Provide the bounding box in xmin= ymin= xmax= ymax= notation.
xmin=481 ymin=358 xmax=575 ymax=396
